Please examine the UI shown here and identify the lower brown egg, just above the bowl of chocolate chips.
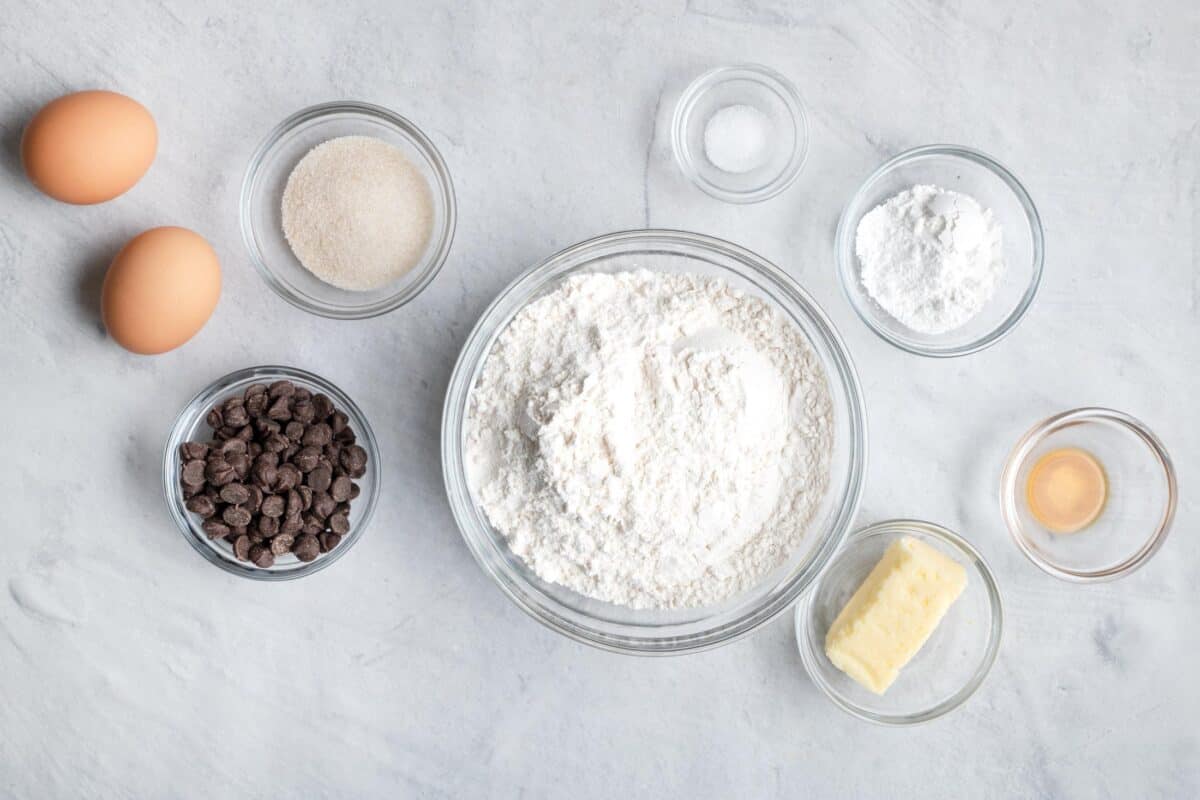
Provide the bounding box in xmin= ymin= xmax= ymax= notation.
xmin=100 ymin=228 xmax=221 ymax=355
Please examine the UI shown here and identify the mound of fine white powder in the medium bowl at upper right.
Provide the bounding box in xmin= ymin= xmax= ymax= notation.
xmin=854 ymin=186 xmax=1004 ymax=333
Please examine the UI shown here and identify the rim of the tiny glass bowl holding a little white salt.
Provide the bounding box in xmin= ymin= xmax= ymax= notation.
xmin=671 ymin=62 xmax=811 ymax=204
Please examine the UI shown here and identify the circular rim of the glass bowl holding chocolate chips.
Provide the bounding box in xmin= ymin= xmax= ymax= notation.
xmin=162 ymin=365 xmax=380 ymax=581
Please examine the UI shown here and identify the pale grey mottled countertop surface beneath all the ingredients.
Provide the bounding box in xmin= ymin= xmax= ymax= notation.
xmin=0 ymin=0 xmax=1200 ymax=798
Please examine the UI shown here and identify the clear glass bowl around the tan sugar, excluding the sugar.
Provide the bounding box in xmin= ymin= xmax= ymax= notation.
xmin=240 ymin=102 xmax=456 ymax=319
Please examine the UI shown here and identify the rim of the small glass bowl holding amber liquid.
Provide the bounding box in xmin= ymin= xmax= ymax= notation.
xmin=1000 ymin=405 xmax=1178 ymax=583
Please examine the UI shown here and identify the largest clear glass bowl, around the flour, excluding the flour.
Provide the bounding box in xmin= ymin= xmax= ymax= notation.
xmin=442 ymin=230 xmax=866 ymax=655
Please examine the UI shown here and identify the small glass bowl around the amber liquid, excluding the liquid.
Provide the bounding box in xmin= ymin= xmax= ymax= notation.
xmin=1000 ymin=408 xmax=1178 ymax=583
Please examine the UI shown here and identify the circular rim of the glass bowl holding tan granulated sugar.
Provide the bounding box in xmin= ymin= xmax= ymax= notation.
xmin=238 ymin=100 xmax=457 ymax=319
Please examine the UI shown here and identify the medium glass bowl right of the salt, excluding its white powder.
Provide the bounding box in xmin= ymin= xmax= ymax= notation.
xmin=834 ymin=144 xmax=1043 ymax=357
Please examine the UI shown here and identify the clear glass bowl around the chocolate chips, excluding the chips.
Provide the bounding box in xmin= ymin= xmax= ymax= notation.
xmin=162 ymin=366 xmax=379 ymax=581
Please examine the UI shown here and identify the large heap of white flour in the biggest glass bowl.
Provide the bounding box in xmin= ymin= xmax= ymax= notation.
xmin=467 ymin=270 xmax=833 ymax=608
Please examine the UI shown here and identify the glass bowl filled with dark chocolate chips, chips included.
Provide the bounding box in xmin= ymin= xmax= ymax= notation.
xmin=163 ymin=366 xmax=379 ymax=581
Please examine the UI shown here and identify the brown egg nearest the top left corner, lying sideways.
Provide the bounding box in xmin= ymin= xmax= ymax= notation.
xmin=20 ymin=91 xmax=158 ymax=205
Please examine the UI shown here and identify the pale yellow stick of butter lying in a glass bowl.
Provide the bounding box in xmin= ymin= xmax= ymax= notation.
xmin=826 ymin=536 xmax=967 ymax=694
